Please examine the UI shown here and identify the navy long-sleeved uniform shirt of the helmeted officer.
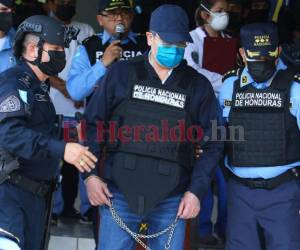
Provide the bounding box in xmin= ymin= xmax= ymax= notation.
xmin=0 ymin=62 xmax=65 ymax=180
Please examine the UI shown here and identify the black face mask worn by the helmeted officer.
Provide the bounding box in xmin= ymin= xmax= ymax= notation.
xmin=34 ymin=50 xmax=66 ymax=76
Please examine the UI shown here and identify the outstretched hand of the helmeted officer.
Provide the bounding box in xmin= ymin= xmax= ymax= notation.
xmin=64 ymin=142 xmax=97 ymax=173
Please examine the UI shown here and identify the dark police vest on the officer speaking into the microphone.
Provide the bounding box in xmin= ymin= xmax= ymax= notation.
xmin=82 ymin=35 xmax=147 ymax=65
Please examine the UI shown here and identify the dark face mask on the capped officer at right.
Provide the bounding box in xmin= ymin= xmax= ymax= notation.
xmin=247 ymin=60 xmax=276 ymax=83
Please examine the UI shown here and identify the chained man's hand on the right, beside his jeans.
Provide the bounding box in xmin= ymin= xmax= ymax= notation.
xmin=177 ymin=191 xmax=200 ymax=220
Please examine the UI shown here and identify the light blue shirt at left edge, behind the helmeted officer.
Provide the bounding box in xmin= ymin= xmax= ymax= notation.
xmin=0 ymin=29 xmax=16 ymax=73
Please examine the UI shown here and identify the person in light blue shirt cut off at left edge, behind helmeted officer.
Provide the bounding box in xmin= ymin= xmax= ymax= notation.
xmin=0 ymin=0 xmax=15 ymax=73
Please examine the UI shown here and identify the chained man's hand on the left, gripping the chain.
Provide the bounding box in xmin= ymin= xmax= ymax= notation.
xmin=86 ymin=176 xmax=113 ymax=207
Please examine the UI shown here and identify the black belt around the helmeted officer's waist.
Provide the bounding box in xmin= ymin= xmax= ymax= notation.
xmin=7 ymin=171 xmax=54 ymax=197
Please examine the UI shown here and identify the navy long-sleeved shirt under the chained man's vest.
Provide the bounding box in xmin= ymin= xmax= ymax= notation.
xmin=83 ymin=53 xmax=223 ymax=198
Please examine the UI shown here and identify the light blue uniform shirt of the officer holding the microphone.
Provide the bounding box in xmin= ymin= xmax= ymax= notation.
xmin=67 ymin=30 xmax=146 ymax=101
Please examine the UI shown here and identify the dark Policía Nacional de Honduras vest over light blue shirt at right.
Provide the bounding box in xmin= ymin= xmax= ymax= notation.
xmin=226 ymin=70 xmax=300 ymax=167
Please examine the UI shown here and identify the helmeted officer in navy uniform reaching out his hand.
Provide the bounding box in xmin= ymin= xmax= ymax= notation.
xmin=0 ymin=16 xmax=97 ymax=250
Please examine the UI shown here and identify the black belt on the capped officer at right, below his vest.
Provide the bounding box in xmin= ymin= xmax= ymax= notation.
xmin=231 ymin=167 xmax=300 ymax=190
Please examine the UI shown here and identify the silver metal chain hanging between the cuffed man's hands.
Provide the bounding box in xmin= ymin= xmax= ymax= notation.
xmin=109 ymin=202 xmax=178 ymax=250
